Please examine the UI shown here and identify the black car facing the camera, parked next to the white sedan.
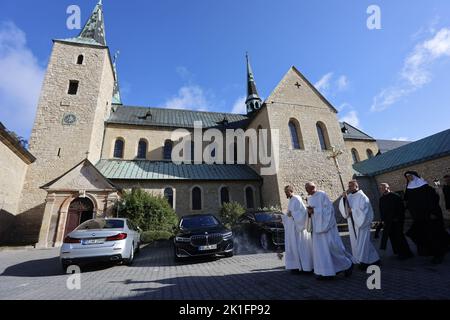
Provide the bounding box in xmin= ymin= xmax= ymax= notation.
xmin=174 ymin=214 xmax=233 ymax=260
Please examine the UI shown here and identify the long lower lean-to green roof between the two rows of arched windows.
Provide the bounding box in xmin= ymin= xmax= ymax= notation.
xmin=96 ymin=160 xmax=261 ymax=181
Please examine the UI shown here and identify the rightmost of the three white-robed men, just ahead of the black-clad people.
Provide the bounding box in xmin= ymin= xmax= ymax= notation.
xmin=339 ymin=180 xmax=380 ymax=270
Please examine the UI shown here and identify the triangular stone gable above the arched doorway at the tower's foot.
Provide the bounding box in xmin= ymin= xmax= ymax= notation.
xmin=40 ymin=159 xmax=119 ymax=190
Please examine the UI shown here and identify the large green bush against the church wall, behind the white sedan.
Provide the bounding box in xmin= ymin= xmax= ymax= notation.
xmin=118 ymin=189 xmax=178 ymax=234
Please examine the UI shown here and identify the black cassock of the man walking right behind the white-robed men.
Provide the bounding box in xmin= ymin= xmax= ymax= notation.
xmin=379 ymin=192 xmax=412 ymax=258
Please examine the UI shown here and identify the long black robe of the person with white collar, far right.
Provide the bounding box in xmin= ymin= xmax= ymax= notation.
xmin=405 ymin=185 xmax=449 ymax=257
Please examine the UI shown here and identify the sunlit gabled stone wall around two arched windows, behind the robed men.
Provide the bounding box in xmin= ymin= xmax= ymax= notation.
xmin=260 ymin=68 xmax=352 ymax=210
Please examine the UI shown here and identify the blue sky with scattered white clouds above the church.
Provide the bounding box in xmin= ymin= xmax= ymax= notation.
xmin=0 ymin=0 xmax=450 ymax=140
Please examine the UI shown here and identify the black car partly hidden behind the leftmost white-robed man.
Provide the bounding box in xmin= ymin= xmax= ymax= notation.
xmin=233 ymin=212 xmax=284 ymax=250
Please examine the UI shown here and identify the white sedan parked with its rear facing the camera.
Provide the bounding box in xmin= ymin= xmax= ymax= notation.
xmin=60 ymin=218 xmax=141 ymax=272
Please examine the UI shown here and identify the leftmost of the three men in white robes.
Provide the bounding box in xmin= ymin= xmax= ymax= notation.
xmin=282 ymin=186 xmax=313 ymax=272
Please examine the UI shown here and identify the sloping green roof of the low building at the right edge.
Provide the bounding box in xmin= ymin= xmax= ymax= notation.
xmin=353 ymin=129 xmax=450 ymax=176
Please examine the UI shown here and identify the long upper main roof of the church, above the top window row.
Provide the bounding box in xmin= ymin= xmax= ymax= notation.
xmin=106 ymin=105 xmax=250 ymax=129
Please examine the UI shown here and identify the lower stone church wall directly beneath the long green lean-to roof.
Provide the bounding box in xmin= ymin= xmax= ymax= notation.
xmin=113 ymin=180 xmax=261 ymax=217
